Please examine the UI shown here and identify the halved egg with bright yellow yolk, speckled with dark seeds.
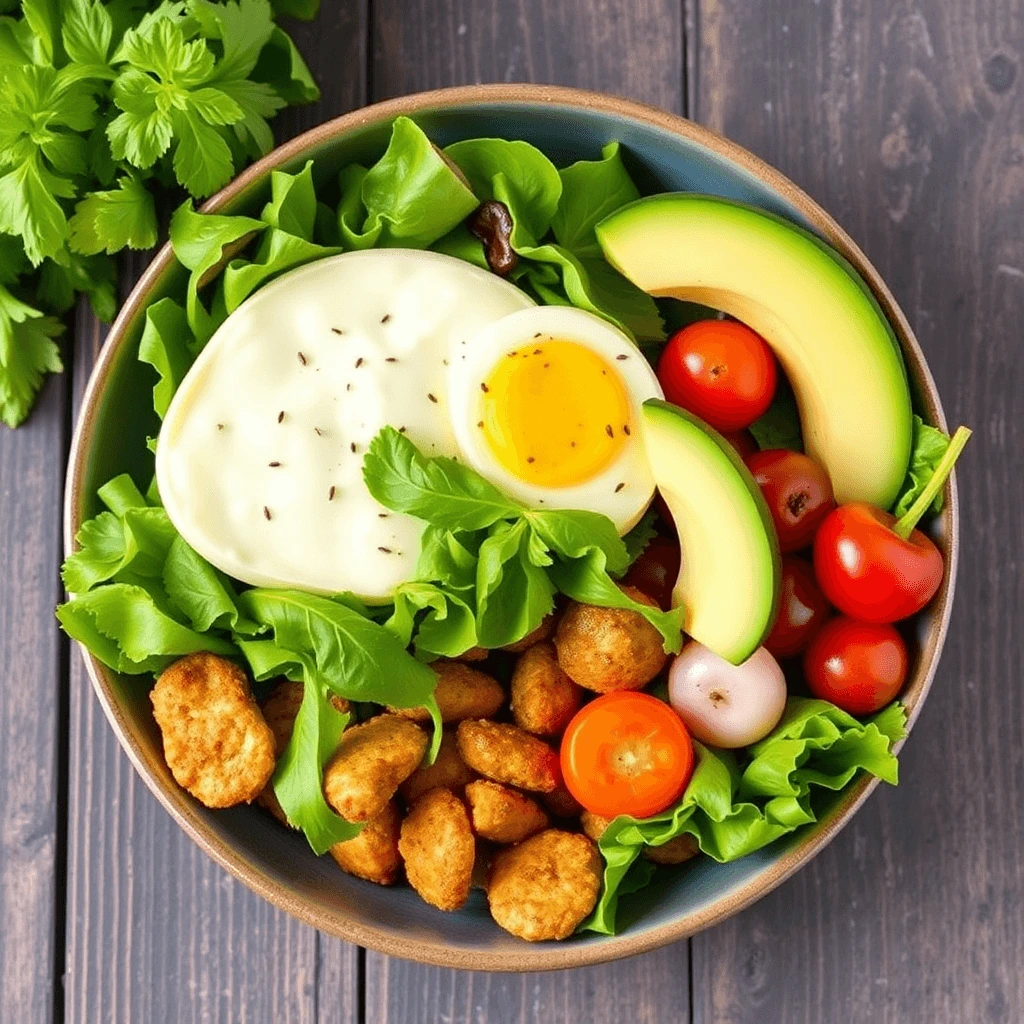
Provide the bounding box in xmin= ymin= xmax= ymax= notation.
xmin=449 ymin=306 xmax=662 ymax=534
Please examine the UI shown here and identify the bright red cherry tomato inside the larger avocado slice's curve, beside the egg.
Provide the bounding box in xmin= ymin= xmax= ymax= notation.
xmin=657 ymin=319 xmax=777 ymax=431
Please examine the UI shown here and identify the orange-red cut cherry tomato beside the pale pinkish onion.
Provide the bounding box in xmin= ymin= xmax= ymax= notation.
xmin=561 ymin=690 xmax=693 ymax=818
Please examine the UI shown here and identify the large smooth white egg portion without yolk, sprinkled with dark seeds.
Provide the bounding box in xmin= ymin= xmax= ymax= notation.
xmin=157 ymin=249 xmax=534 ymax=602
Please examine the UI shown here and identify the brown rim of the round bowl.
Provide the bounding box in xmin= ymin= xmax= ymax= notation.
xmin=63 ymin=84 xmax=959 ymax=972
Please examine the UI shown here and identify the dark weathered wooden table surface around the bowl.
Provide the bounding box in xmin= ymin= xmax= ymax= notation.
xmin=0 ymin=0 xmax=1024 ymax=1024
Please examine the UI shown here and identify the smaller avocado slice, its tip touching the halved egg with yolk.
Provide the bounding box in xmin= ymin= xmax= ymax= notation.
xmin=642 ymin=398 xmax=781 ymax=665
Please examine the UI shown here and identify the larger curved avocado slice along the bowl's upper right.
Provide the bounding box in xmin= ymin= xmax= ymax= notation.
xmin=597 ymin=193 xmax=912 ymax=509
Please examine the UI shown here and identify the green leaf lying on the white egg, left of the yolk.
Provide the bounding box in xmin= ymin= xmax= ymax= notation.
xmin=362 ymin=427 xmax=521 ymax=531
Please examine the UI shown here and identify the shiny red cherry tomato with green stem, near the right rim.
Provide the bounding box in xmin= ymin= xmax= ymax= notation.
xmin=814 ymin=502 xmax=943 ymax=623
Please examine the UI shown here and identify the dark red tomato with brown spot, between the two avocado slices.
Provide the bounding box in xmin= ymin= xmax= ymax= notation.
xmin=746 ymin=449 xmax=836 ymax=554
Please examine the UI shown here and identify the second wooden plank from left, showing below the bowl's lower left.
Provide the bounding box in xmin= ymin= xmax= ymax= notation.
xmin=62 ymin=3 xmax=366 ymax=1024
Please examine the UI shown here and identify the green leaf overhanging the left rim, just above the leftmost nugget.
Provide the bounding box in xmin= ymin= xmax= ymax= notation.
xmin=56 ymin=583 xmax=236 ymax=675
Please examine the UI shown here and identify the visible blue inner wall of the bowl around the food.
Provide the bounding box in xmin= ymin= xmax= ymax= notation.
xmin=83 ymin=101 xmax=921 ymax=967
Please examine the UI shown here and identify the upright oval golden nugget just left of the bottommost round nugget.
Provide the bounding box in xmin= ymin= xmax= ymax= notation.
xmin=398 ymin=790 xmax=476 ymax=910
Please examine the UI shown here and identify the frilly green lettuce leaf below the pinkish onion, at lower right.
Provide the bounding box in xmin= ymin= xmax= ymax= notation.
xmin=581 ymin=697 xmax=906 ymax=935
